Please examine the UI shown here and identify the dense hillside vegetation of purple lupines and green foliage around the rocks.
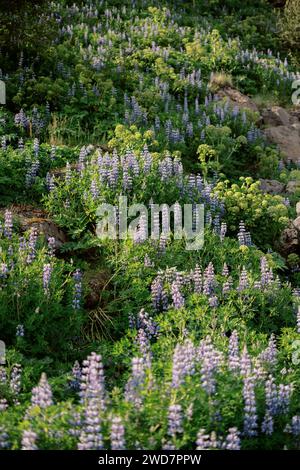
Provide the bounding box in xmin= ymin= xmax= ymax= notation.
xmin=0 ymin=0 xmax=300 ymax=450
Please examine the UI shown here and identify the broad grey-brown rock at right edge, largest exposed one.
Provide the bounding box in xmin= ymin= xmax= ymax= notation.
xmin=264 ymin=124 xmax=300 ymax=163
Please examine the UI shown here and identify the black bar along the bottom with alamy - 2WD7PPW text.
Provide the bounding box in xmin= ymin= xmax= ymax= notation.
xmin=0 ymin=450 xmax=300 ymax=470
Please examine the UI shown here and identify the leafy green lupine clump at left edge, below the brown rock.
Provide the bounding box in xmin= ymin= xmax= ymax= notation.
xmin=0 ymin=226 xmax=83 ymax=358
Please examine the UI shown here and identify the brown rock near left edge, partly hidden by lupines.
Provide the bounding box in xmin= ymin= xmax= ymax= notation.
xmin=1 ymin=205 xmax=67 ymax=248
